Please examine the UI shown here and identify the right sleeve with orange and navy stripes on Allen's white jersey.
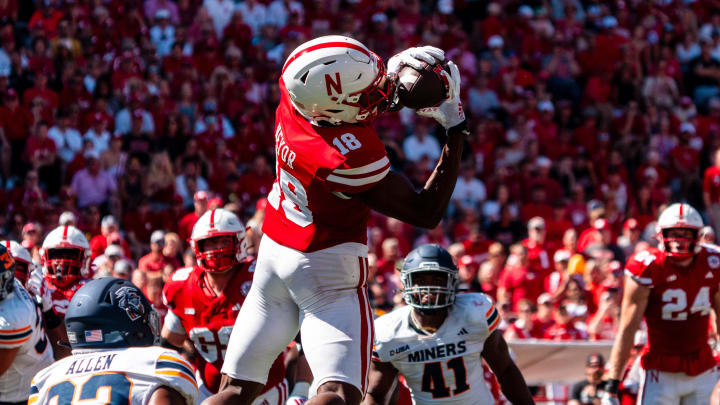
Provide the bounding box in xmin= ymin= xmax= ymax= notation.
xmin=154 ymin=350 xmax=198 ymax=405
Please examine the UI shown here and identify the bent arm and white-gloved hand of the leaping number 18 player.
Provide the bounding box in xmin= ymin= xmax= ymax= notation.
xmin=356 ymin=62 xmax=468 ymax=229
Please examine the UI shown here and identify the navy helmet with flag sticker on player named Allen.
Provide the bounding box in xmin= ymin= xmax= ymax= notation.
xmin=65 ymin=277 xmax=160 ymax=349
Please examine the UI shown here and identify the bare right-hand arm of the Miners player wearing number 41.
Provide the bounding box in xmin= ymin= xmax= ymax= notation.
xmin=482 ymin=330 xmax=535 ymax=405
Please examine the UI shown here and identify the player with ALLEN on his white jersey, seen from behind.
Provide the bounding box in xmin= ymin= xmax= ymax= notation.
xmin=27 ymin=277 xmax=198 ymax=405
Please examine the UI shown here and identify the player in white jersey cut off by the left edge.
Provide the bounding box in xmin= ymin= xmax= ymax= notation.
xmin=0 ymin=245 xmax=53 ymax=405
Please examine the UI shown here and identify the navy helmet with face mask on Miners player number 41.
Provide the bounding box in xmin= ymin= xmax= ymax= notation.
xmin=400 ymin=244 xmax=459 ymax=311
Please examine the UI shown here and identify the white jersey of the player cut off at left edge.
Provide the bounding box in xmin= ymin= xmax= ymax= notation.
xmin=0 ymin=280 xmax=53 ymax=403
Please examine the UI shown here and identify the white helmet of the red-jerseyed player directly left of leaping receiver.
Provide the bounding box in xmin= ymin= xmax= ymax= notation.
xmin=190 ymin=208 xmax=247 ymax=272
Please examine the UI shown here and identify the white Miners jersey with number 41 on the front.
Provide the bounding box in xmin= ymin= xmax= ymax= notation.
xmin=373 ymin=293 xmax=500 ymax=405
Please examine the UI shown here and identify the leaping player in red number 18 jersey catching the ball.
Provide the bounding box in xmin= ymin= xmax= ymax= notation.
xmin=206 ymin=36 xmax=468 ymax=405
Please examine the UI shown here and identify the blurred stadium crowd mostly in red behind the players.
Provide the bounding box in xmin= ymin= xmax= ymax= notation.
xmin=0 ymin=0 xmax=720 ymax=354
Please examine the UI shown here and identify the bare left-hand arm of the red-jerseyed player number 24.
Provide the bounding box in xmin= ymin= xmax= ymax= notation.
xmin=603 ymin=275 xmax=650 ymax=403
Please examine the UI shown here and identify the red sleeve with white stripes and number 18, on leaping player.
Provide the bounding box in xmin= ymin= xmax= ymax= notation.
xmin=325 ymin=126 xmax=390 ymax=194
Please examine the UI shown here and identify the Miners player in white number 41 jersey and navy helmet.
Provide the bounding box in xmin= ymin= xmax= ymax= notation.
xmin=363 ymin=245 xmax=534 ymax=405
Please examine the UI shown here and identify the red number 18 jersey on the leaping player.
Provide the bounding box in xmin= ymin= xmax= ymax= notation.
xmin=263 ymin=79 xmax=390 ymax=252
